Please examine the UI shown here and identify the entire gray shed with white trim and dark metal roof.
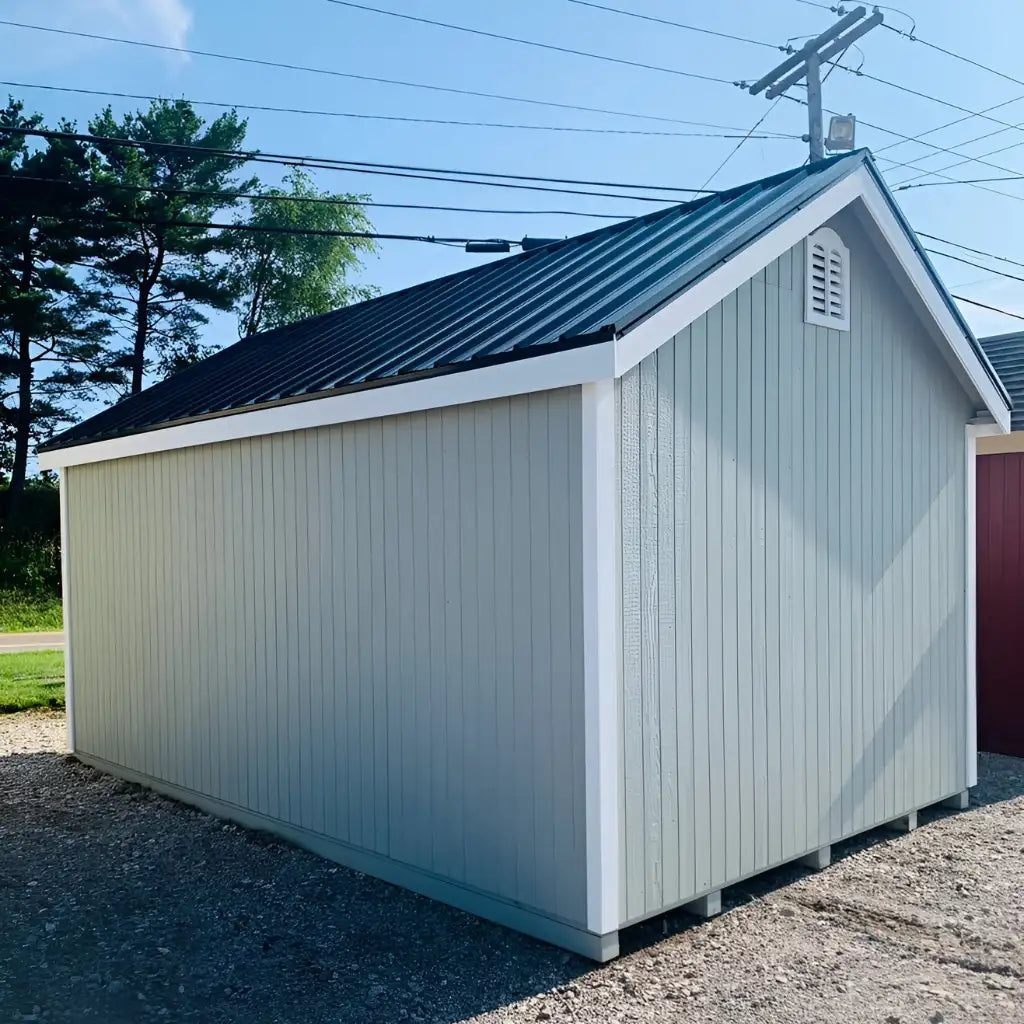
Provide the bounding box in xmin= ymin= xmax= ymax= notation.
xmin=40 ymin=152 xmax=1010 ymax=959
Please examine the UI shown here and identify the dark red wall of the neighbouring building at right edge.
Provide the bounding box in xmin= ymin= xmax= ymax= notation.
xmin=978 ymin=453 xmax=1024 ymax=757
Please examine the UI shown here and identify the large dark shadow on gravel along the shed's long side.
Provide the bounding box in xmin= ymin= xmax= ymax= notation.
xmin=0 ymin=754 xmax=595 ymax=1024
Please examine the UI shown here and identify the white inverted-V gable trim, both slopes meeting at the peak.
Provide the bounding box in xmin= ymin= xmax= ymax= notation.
xmin=615 ymin=167 xmax=1010 ymax=433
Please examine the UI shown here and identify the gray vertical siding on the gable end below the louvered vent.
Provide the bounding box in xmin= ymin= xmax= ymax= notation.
xmin=618 ymin=215 xmax=973 ymax=923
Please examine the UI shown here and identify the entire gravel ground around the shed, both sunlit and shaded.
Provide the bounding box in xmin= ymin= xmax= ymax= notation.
xmin=0 ymin=713 xmax=1024 ymax=1024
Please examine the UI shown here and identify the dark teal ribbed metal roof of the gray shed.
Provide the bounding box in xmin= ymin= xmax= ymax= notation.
xmin=42 ymin=151 xmax=994 ymax=451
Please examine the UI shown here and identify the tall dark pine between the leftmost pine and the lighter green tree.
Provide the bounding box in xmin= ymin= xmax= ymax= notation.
xmin=89 ymin=99 xmax=256 ymax=393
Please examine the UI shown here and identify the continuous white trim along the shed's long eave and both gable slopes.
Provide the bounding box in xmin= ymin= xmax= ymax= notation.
xmin=39 ymin=166 xmax=1010 ymax=469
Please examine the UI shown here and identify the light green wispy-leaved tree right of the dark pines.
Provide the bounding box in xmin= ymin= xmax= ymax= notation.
xmin=229 ymin=169 xmax=376 ymax=338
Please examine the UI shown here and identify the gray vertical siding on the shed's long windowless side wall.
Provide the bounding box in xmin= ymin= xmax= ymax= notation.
xmin=67 ymin=389 xmax=586 ymax=925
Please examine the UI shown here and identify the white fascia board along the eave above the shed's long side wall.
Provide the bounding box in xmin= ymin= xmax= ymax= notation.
xmin=39 ymin=341 xmax=614 ymax=469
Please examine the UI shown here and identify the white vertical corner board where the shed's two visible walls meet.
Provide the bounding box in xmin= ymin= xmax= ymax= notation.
xmin=582 ymin=378 xmax=620 ymax=935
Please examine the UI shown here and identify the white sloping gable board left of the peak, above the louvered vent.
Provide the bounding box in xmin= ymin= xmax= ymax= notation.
xmin=615 ymin=172 xmax=863 ymax=377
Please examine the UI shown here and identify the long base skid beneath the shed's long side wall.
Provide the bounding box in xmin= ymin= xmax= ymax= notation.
xmin=75 ymin=751 xmax=618 ymax=964
